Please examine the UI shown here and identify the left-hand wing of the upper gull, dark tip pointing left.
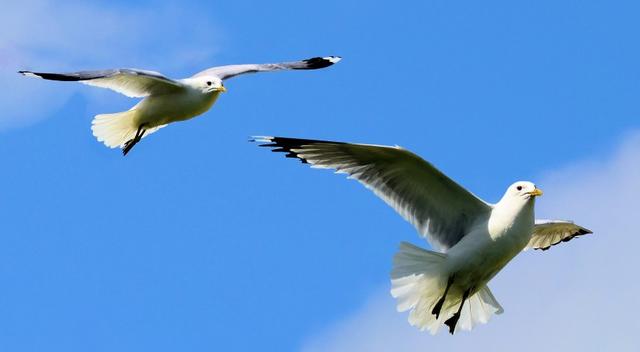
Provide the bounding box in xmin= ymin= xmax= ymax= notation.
xmin=19 ymin=68 xmax=184 ymax=98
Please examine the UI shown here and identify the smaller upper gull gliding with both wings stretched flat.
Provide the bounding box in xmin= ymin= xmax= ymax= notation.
xmin=18 ymin=56 xmax=341 ymax=155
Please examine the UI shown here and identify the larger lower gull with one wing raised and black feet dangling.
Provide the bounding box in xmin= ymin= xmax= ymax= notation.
xmin=252 ymin=137 xmax=592 ymax=334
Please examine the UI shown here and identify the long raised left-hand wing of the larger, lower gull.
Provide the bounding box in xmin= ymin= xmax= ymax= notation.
xmin=255 ymin=137 xmax=492 ymax=251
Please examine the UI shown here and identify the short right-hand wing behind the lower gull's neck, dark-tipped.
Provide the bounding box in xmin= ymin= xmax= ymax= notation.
xmin=525 ymin=220 xmax=593 ymax=251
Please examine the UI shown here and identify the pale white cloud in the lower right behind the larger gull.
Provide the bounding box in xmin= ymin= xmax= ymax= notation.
xmin=303 ymin=132 xmax=640 ymax=352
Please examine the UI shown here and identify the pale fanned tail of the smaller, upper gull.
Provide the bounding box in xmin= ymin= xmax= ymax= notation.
xmin=91 ymin=108 xmax=165 ymax=148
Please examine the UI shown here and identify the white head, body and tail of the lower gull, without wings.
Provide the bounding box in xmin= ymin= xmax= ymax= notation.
xmin=391 ymin=182 xmax=537 ymax=333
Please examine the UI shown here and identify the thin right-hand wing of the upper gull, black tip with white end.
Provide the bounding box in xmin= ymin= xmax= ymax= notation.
xmin=194 ymin=56 xmax=342 ymax=80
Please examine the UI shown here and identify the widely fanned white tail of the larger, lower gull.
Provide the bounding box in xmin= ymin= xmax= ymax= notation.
xmin=391 ymin=242 xmax=503 ymax=334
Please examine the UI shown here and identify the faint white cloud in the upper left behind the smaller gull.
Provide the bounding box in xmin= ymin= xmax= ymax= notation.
xmin=0 ymin=0 xmax=220 ymax=130
